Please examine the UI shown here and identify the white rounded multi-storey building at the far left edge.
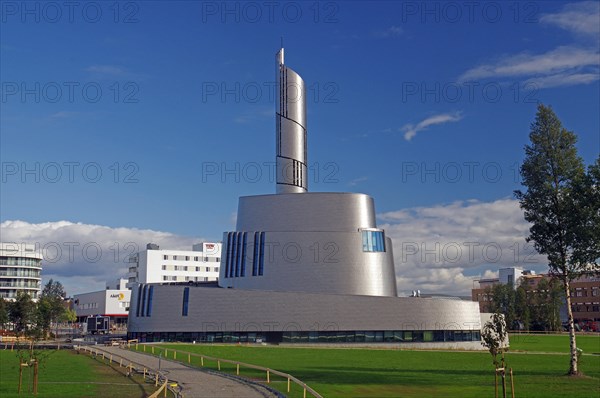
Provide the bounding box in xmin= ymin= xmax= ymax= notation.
xmin=0 ymin=243 xmax=43 ymax=301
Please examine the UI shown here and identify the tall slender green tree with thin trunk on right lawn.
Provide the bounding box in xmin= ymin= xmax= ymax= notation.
xmin=515 ymin=104 xmax=600 ymax=375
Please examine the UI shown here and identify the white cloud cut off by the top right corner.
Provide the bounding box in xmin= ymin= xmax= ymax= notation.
xmin=540 ymin=1 xmax=600 ymax=40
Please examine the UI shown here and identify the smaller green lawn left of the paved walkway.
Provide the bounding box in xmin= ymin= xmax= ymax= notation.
xmin=0 ymin=349 xmax=155 ymax=398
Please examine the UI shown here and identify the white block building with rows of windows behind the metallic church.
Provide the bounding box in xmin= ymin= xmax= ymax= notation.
xmin=127 ymin=242 xmax=221 ymax=289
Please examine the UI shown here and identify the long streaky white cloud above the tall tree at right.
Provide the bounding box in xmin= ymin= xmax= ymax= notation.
xmin=459 ymin=46 xmax=600 ymax=82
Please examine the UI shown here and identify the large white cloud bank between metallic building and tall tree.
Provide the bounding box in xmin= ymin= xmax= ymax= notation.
xmin=378 ymin=199 xmax=547 ymax=295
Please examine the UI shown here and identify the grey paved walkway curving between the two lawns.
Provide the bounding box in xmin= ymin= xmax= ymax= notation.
xmin=93 ymin=345 xmax=277 ymax=398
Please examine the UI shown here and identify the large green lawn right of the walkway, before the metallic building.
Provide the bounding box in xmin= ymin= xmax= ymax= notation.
xmin=131 ymin=336 xmax=600 ymax=398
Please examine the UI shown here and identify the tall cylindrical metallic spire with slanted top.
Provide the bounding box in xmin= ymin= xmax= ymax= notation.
xmin=275 ymin=47 xmax=308 ymax=193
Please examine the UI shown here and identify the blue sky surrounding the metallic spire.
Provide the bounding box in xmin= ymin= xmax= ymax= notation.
xmin=0 ymin=1 xmax=600 ymax=293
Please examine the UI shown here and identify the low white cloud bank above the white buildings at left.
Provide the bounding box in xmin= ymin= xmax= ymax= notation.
xmin=0 ymin=220 xmax=203 ymax=295
